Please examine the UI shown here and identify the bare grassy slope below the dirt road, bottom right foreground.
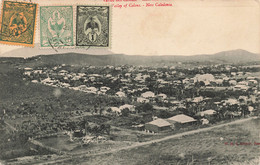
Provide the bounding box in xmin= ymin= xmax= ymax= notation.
xmin=60 ymin=119 xmax=260 ymax=165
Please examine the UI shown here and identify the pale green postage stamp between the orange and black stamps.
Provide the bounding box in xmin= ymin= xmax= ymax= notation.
xmin=40 ymin=6 xmax=74 ymax=48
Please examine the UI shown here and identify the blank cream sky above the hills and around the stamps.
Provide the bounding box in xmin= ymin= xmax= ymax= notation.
xmin=0 ymin=0 xmax=260 ymax=56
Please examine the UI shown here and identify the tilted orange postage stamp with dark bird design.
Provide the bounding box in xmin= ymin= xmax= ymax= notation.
xmin=0 ymin=1 xmax=37 ymax=47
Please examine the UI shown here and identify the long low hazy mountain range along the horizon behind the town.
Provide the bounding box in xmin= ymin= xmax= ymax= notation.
xmin=1 ymin=49 xmax=260 ymax=66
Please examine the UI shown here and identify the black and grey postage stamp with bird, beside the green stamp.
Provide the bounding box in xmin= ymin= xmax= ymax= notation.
xmin=76 ymin=6 xmax=110 ymax=47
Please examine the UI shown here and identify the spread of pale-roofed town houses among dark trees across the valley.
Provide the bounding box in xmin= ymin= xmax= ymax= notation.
xmin=18 ymin=64 xmax=260 ymax=132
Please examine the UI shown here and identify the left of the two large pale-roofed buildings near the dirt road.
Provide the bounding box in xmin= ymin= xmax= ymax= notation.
xmin=144 ymin=118 xmax=171 ymax=133
